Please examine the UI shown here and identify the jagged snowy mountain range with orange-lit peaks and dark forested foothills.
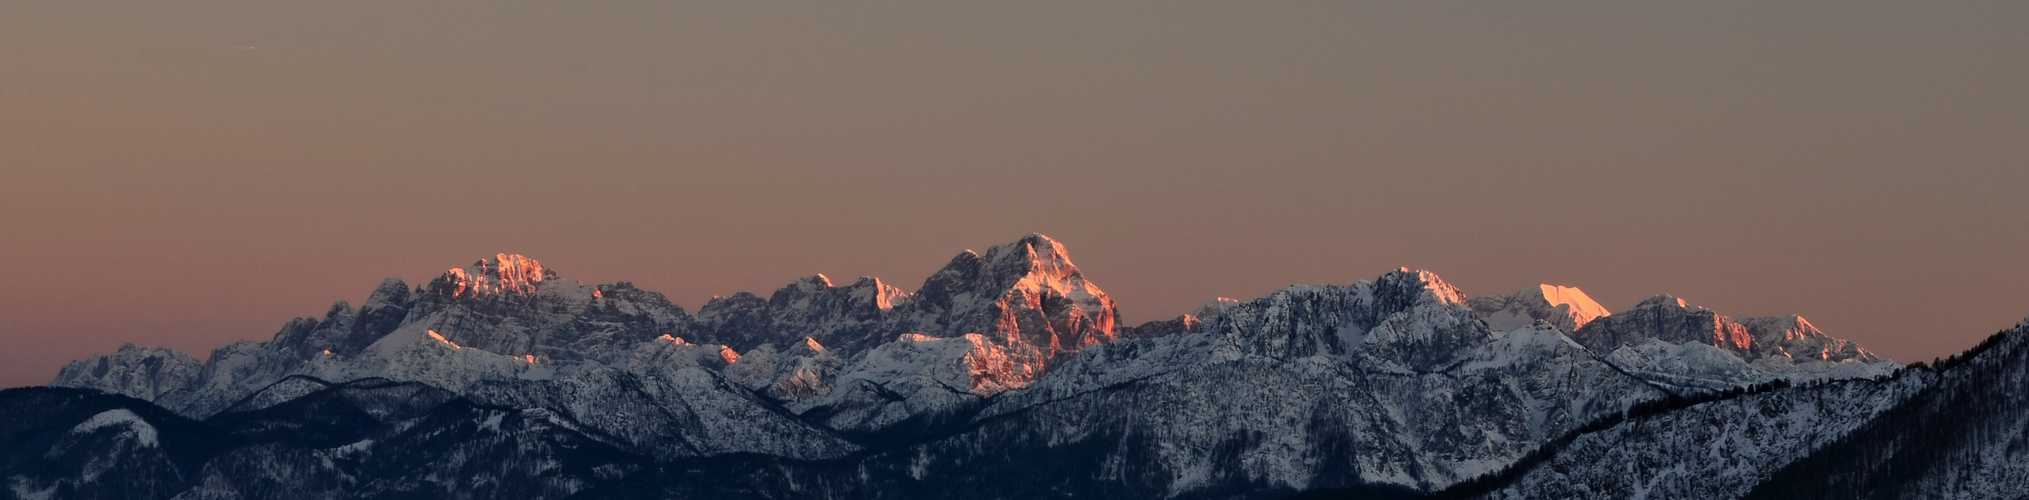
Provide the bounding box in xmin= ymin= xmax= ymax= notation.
xmin=15 ymin=234 xmax=1964 ymax=498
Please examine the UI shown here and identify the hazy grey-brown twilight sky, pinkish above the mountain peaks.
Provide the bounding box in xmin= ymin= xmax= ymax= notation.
xmin=0 ymin=2 xmax=2029 ymax=386
